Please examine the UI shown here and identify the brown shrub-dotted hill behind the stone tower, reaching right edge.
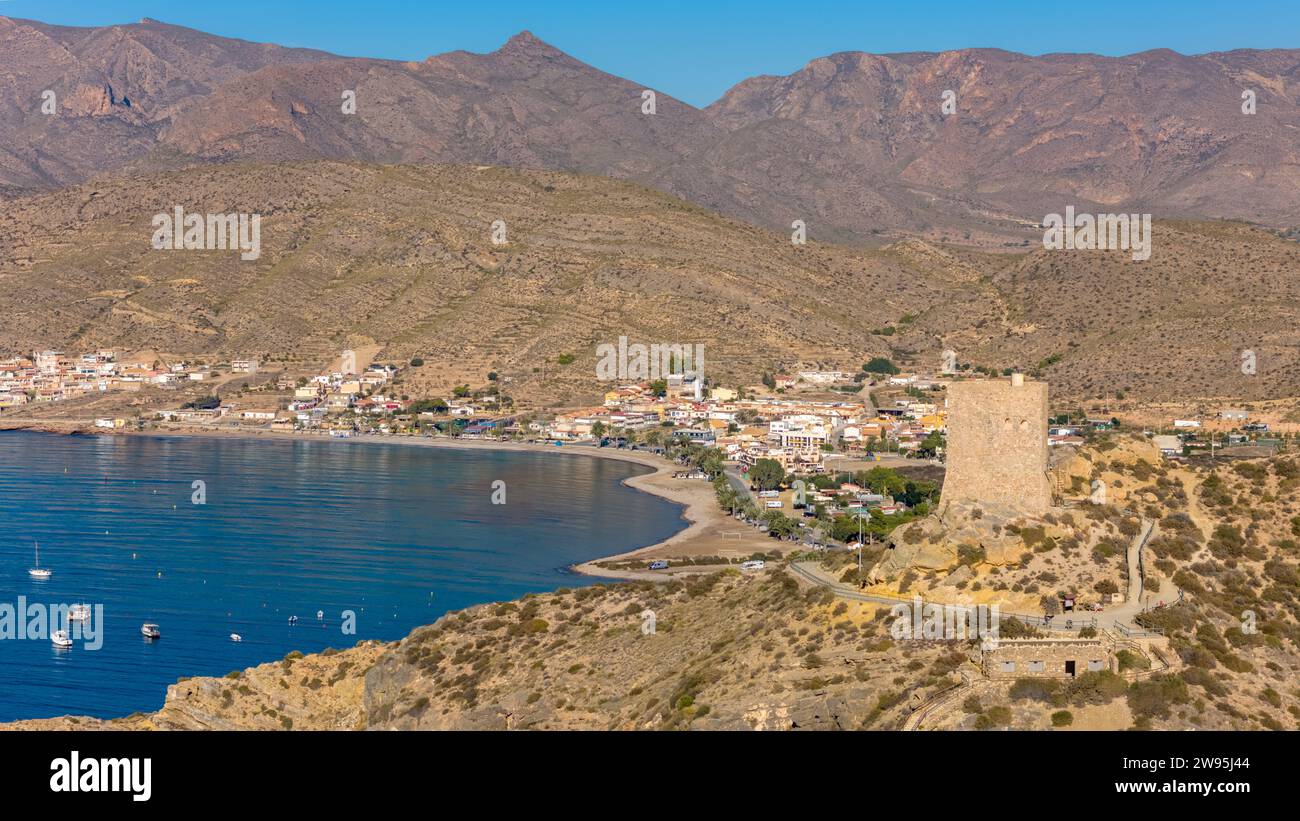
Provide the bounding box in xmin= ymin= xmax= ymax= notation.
xmin=961 ymin=222 xmax=1300 ymax=400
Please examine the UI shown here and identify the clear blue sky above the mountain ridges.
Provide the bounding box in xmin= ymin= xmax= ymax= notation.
xmin=0 ymin=0 xmax=1300 ymax=105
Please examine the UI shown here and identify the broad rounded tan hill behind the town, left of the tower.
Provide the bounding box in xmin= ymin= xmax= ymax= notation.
xmin=0 ymin=162 xmax=993 ymax=405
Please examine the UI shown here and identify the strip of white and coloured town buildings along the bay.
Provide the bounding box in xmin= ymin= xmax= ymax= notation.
xmin=0 ymin=349 xmax=1295 ymax=480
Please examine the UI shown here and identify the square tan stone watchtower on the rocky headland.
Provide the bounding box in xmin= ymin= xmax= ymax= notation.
xmin=941 ymin=374 xmax=1052 ymax=514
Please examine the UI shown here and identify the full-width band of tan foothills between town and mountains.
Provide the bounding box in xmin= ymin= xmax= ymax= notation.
xmin=0 ymin=162 xmax=1300 ymax=400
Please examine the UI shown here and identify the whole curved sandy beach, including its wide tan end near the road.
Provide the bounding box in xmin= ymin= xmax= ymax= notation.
xmin=0 ymin=420 xmax=774 ymax=581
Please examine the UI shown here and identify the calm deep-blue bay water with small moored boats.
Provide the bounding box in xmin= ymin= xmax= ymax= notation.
xmin=0 ymin=433 xmax=685 ymax=721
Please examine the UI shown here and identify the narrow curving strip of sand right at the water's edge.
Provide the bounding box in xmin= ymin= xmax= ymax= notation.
xmin=0 ymin=422 xmax=731 ymax=581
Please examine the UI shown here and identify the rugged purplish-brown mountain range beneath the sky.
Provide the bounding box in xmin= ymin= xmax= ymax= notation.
xmin=0 ymin=17 xmax=1300 ymax=246
